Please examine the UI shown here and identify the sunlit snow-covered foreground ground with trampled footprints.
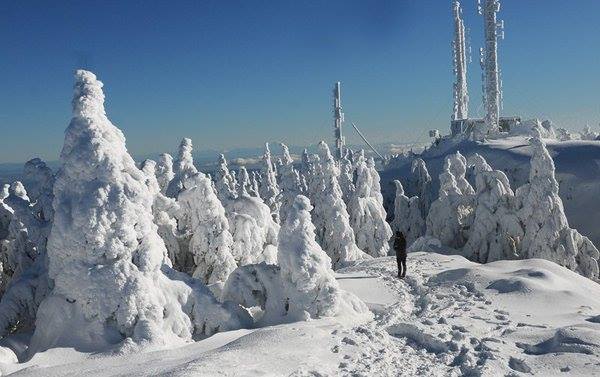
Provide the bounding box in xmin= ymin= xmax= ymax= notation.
xmin=0 ymin=253 xmax=600 ymax=376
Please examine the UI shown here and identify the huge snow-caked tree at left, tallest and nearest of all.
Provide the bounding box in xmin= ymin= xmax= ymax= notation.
xmin=30 ymin=70 xmax=250 ymax=352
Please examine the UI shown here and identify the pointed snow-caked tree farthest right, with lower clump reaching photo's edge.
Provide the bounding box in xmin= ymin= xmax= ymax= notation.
xmin=516 ymin=135 xmax=599 ymax=278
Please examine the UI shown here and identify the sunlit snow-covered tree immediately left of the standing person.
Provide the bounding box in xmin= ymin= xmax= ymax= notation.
xmin=348 ymin=154 xmax=392 ymax=257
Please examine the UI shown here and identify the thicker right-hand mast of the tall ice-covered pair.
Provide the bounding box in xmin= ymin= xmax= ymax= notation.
xmin=477 ymin=0 xmax=504 ymax=132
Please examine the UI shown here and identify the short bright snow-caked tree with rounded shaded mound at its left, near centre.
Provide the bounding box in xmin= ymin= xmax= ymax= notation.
xmin=223 ymin=196 xmax=370 ymax=325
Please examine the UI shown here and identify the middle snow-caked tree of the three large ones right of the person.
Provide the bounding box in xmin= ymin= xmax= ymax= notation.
xmin=462 ymin=155 xmax=523 ymax=263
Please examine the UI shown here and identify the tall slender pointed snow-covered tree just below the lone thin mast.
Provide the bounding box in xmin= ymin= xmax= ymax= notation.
xmin=309 ymin=141 xmax=366 ymax=269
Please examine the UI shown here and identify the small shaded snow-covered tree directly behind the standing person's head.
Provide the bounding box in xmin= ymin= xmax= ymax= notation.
xmin=392 ymin=180 xmax=425 ymax=246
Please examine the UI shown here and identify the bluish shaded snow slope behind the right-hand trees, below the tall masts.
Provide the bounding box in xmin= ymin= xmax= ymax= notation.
xmin=381 ymin=136 xmax=600 ymax=245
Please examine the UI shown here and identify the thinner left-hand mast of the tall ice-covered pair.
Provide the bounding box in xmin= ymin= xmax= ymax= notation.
xmin=452 ymin=0 xmax=469 ymax=120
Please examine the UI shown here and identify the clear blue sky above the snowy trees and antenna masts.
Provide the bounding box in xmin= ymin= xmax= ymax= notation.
xmin=0 ymin=0 xmax=600 ymax=162
